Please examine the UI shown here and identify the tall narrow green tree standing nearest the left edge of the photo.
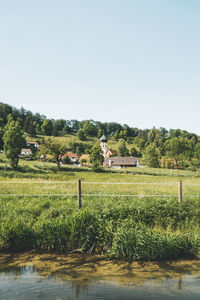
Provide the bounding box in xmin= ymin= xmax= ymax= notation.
xmin=3 ymin=119 xmax=26 ymax=169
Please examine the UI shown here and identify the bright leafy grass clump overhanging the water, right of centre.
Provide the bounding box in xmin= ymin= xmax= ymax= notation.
xmin=109 ymin=223 xmax=192 ymax=261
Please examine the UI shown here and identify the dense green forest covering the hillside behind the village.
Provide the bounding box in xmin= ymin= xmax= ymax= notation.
xmin=0 ymin=103 xmax=200 ymax=170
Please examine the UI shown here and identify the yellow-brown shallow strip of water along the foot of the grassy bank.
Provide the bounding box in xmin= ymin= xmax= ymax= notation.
xmin=0 ymin=251 xmax=200 ymax=285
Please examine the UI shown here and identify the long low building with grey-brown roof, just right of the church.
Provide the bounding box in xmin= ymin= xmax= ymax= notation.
xmin=103 ymin=156 xmax=140 ymax=169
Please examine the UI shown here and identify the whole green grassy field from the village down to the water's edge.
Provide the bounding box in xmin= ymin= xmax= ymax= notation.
xmin=0 ymin=157 xmax=200 ymax=260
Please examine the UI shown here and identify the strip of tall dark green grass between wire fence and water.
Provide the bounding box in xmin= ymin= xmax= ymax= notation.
xmin=0 ymin=192 xmax=200 ymax=261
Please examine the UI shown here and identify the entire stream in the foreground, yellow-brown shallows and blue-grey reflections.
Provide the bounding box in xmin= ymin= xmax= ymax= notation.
xmin=0 ymin=253 xmax=200 ymax=300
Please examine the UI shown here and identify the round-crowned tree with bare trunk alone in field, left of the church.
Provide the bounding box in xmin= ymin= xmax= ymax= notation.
xmin=39 ymin=138 xmax=67 ymax=171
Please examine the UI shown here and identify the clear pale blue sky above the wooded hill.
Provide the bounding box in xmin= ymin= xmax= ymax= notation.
xmin=0 ymin=0 xmax=200 ymax=134
